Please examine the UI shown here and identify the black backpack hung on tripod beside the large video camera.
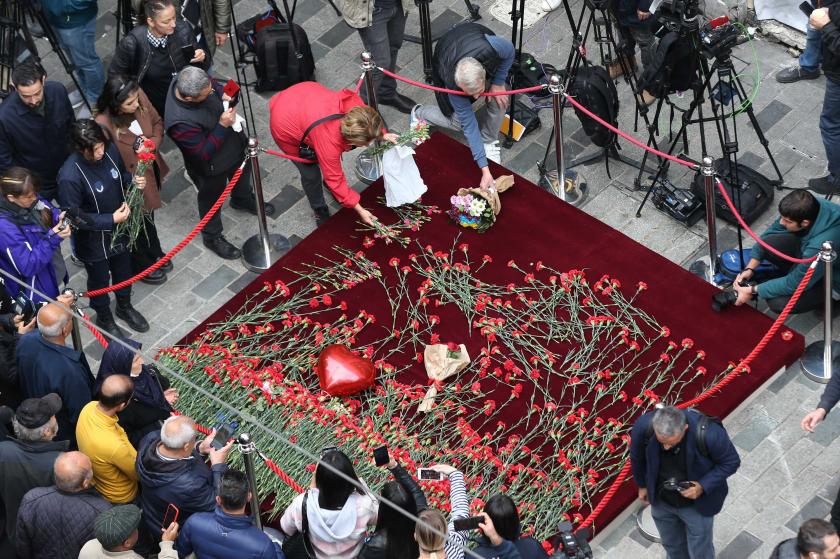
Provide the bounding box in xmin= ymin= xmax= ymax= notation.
xmin=639 ymin=31 xmax=697 ymax=97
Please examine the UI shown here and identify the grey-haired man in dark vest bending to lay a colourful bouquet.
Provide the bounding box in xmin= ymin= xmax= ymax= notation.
xmin=411 ymin=23 xmax=516 ymax=188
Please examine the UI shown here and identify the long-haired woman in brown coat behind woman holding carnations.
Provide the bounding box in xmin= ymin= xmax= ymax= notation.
xmin=96 ymin=75 xmax=172 ymax=285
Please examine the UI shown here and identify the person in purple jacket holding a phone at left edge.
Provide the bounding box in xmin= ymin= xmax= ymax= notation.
xmin=0 ymin=167 xmax=70 ymax=303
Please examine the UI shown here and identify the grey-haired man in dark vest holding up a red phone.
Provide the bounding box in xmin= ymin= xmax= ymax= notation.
xmin=163 ymin=66 xmax=274 ymax=260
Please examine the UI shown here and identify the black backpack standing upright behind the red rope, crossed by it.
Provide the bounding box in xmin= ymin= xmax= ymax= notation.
xmin=569 ymin=65 xmax=618 ymax=147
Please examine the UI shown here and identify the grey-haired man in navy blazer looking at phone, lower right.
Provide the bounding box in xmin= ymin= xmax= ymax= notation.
xmin=630 ymin=406 xmax=741 ymax=559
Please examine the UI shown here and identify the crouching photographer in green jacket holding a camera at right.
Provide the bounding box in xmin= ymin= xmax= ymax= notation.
xmin=733 ymin=190 xmax=840 ymax=313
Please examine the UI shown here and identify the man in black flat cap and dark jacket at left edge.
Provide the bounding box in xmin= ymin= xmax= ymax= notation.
xmin=0 ymin=394 xmax=68 ymax=557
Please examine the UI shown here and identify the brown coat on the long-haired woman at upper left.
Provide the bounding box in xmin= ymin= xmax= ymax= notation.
xmin=96 ymin=89 xmax=169 ymax=210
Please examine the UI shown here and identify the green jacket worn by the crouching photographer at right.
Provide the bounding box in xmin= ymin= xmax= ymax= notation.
xmin=750 ymin=198 xmax=840 ymax=299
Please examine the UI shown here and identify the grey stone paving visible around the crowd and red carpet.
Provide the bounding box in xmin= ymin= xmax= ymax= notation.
xmin=26 ymin=0 xmax=840 ymax=559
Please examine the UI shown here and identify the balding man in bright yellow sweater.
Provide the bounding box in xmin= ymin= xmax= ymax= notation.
xmin=76 ymin=375 xmax=137 ymax=505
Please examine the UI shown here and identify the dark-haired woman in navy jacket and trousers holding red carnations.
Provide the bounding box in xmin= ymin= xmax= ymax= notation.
xmin=58 ymin=119 xmax=149 ymax=337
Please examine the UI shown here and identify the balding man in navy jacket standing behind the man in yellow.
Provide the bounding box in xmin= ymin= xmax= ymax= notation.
xmin=17 ymin=296 xmax=93 ymax=446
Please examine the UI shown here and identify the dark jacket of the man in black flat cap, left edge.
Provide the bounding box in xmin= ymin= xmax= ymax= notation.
xmin=0 ymin=439 xmax=70 ymax=539
